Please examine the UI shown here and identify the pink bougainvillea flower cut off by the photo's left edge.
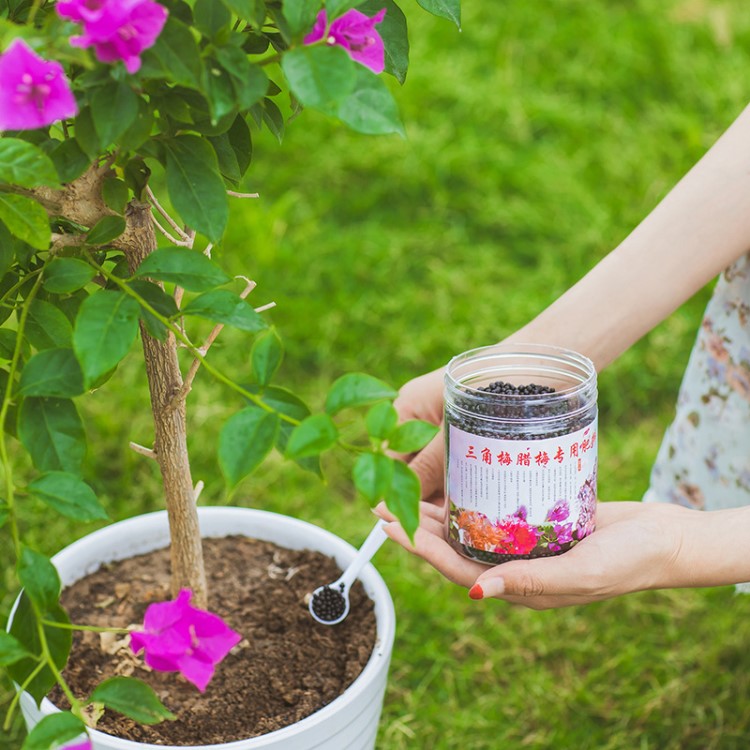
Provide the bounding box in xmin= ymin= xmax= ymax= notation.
xmin=0 ymin=39 xmax=78 ymax=130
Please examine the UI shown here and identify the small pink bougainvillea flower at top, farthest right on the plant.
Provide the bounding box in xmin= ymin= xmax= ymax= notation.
xmin=303 ymin=8 xmax=385 ymax=73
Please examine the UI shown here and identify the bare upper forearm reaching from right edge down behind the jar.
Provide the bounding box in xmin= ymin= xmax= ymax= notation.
xmin=507 ymin=103 xmax=750 ymax=369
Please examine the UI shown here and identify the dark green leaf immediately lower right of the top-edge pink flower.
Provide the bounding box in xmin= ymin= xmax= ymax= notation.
xmin=139 ymin=15 xmax=205 ymax=91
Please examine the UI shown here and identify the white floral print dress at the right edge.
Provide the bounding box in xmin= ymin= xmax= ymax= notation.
xmin=643 ymin=253 xmax=750 ymax=510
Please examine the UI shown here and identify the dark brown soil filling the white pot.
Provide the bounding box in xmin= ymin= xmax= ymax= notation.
xmin=51 ymin=537 xmax=376 ymax=745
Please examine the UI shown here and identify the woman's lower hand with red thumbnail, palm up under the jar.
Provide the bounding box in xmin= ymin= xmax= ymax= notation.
xmin=376 ymin=502 xmax=704 ymax=609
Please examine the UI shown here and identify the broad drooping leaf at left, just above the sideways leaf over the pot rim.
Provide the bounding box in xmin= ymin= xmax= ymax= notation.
xmin=18 ymin=397 xmax=86 ymax=474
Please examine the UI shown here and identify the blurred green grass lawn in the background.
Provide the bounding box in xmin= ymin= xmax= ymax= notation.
xmin=7 ymin=0 xmax=750 ymax=750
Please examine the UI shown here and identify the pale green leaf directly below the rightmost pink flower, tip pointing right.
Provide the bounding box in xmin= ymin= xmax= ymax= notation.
xmin=336 ymin=65 xmax=404 ymax=135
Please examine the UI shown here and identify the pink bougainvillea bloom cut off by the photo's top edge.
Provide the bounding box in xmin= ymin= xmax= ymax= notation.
xmin=57 ymin=0 xmax=168 ymax=73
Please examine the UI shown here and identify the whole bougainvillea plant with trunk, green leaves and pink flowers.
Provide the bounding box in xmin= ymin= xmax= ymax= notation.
xmin=0 ymin=0 xmax=459 ymax=750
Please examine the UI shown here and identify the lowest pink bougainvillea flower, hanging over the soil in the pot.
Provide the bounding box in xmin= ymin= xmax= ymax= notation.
xmin=130 ymin=589 xmax=242 ymax=692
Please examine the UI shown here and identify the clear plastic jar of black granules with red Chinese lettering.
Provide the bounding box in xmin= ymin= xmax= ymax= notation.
xmin=445 ymin=344 xmax=597 ymax=565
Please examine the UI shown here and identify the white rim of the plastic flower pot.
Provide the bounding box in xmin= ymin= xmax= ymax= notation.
xmin=13 ymin=506 xmax=396 ymax=750
